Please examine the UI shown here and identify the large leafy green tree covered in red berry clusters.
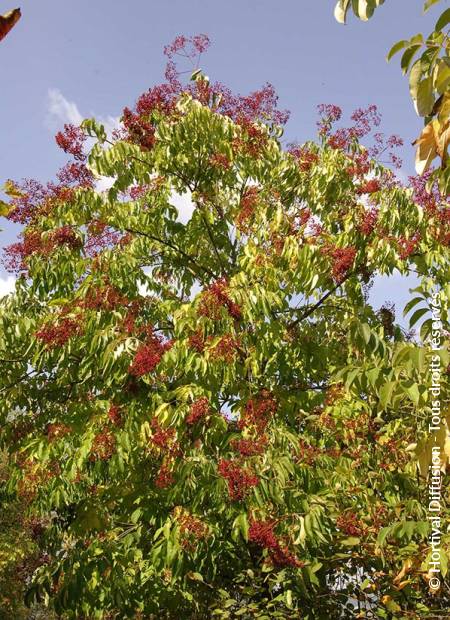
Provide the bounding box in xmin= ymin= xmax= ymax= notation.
xmin=0 ymin=35 xmax=449 ymax=619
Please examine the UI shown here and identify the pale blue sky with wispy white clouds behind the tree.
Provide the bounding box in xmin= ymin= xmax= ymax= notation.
xmin=0 ymin=0 xmax=436 ymax=314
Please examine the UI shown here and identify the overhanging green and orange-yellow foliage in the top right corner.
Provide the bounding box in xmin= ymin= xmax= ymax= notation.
xmin=334 ymin=0 xmax=450 ymax=196
